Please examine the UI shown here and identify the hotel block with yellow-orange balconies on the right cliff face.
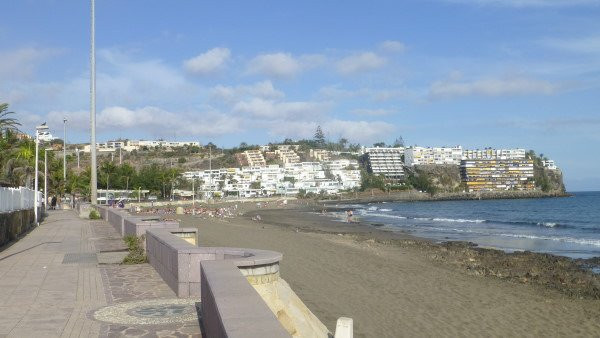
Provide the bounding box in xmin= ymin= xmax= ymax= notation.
xmin=460 ymin=159 xmax=535 ymax=192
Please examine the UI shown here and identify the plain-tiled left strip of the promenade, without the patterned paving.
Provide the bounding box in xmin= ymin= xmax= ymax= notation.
xmin=0 ymin=211 xmax=106 ymax=337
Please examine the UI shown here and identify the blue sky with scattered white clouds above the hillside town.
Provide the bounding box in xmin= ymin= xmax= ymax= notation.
xmin=0 ymin=0 xmax=600 ymax=191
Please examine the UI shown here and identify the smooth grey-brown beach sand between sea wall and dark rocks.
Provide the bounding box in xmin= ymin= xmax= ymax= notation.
xmin=171 ymin=203 xmax=600 ymax=337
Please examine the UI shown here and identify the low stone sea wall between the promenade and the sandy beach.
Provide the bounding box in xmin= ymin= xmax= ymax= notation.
xmin=96 ymin=206 xmax=338 ymax=337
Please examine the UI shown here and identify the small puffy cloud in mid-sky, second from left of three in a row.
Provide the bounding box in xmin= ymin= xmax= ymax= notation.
xmin=247 ymin=53 xmax=302 ymax=78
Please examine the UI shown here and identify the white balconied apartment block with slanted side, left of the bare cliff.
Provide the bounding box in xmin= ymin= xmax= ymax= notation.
xmin=363 ymin=147 xmax=404 ymax=180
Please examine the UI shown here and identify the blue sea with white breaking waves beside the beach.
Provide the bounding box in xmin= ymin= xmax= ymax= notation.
xmin=338 ymin=192 xmax=600 ymax=258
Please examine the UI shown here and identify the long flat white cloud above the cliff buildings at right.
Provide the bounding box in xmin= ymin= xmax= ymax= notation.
xmin=429 ymin=77 xmax=558 ymax=98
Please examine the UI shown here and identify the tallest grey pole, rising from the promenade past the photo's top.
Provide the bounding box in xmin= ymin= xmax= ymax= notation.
xmin=90 ymin=0 xmax=98 ymax=205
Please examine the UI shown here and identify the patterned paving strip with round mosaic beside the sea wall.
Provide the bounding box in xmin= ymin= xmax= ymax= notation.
xmin=88 ymin=221 xmax=202 ymax=337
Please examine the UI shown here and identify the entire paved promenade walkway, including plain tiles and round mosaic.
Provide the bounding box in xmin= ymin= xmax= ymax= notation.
xmin=0 ymin=210 xmax=200 ymax=337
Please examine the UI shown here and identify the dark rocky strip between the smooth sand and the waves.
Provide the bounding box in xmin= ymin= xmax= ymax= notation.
xmin=251 ymin=207 xmax=600 ymax=300
